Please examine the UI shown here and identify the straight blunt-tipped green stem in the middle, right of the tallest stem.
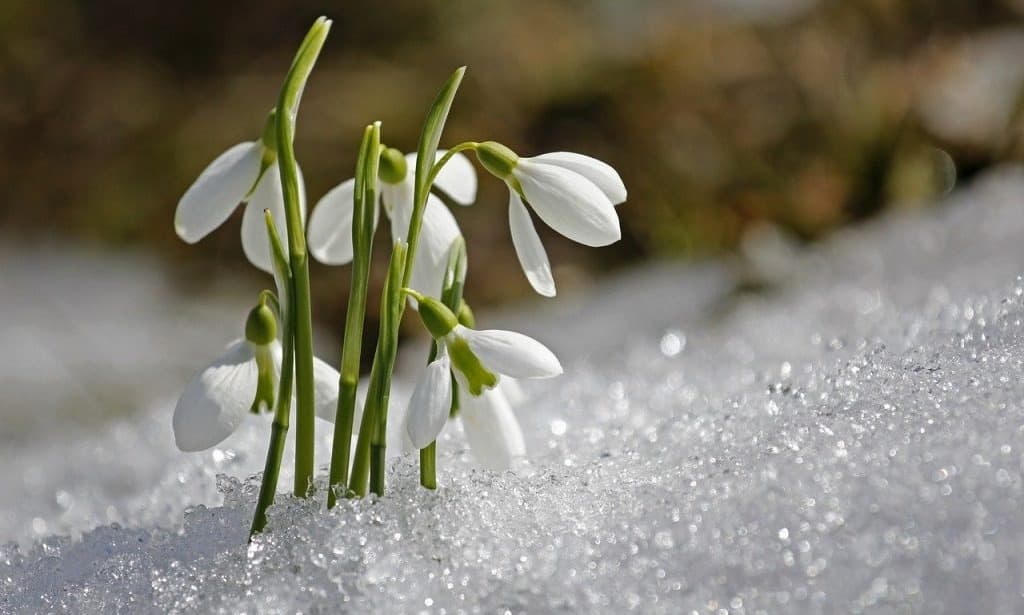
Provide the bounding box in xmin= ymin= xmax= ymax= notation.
xmin=327 ymin=122 xmax=381 ymax=508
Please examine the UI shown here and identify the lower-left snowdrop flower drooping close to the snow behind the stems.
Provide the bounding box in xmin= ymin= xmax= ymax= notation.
xmin=172 ymin=305 xmax=338 ymax=452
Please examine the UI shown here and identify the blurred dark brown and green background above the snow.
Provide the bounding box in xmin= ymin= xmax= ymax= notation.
xmin=0 ymin=0 xmax=1024 ymax=429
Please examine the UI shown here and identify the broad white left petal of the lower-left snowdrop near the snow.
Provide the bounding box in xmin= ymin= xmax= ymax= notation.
xmin=171 ymin=340 xmax=258 ymax=452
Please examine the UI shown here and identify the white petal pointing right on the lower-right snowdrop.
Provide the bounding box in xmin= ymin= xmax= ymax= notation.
xmin=456 ymin=326 xmax=562 ymax=378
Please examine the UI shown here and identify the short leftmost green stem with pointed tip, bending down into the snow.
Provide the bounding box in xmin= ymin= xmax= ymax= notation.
xmin=249 ymin=211 xmax=295 ymax=539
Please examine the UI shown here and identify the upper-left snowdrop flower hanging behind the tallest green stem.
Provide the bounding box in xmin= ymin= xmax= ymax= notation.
xmin=174 ymin=113 xmax=306 ymax=273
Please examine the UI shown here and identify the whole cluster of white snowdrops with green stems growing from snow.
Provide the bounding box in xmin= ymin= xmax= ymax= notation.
xmin=173 ymin=14 xmax=626 ymax=532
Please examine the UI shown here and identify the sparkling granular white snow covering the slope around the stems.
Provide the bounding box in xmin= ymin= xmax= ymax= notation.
xmin=6 ymin=170 xmax=1024 ymax=614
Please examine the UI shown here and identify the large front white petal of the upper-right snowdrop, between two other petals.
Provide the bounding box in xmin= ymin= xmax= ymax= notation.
xmin=513 ymin=159 xmax=622 ymax=248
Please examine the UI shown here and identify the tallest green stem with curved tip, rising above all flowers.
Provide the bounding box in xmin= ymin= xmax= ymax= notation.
xmin=275 ymin=17 xmax=331 ymax=497
